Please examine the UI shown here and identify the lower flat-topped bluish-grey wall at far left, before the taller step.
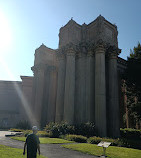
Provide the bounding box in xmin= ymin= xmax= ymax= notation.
xmin=0 ymin=81 xmax=21 ymax=128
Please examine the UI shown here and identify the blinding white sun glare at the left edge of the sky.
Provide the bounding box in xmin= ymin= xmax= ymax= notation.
xmin=0 ymin=12 xmax=12 ymax=51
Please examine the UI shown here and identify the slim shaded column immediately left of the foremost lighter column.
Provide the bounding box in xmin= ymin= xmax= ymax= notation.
xmin=86 ymin=45 xmax=95 ymax=122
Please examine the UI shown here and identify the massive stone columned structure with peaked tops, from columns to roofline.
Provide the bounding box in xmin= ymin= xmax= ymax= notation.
xmin=32 ymin=15 xmax=126 ymax=137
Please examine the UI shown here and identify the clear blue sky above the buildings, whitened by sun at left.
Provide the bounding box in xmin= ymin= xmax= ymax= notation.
xmin=0 ymin=0 xmax=141 ymax=80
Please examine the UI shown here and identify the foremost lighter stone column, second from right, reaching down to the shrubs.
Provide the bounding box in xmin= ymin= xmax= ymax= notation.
xmin=95 ymin=41 xmax=107 ymax=137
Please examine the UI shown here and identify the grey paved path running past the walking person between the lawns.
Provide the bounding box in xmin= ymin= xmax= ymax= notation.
xmin=0 ymin=131 xmax=97 ymax=158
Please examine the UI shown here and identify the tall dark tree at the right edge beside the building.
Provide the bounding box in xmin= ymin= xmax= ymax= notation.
xmin=124 ymin=43 xmax=141 ymax=128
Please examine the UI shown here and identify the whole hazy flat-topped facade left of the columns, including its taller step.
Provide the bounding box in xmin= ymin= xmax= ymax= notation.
xmin=0 ymin=76 xmax=33 ymax=129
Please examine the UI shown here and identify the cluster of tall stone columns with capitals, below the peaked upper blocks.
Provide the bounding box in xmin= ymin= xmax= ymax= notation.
xmin=33 ymin=40 xmax=119 ymax=137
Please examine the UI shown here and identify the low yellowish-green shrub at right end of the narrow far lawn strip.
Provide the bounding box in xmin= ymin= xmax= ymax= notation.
xmin=65 ymin=134 xmax=87 ymax=143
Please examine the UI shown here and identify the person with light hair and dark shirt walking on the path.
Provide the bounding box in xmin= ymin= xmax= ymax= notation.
xmin=23 ymin=126 xmax=40 ymax=158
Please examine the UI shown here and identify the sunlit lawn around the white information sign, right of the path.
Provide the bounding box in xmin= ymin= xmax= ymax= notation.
xmin=62 ymin=143 xmax=141 ymax=158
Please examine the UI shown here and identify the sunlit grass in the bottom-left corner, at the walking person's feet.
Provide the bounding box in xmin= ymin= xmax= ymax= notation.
xmin=0 ymin=145 xmax=46 ymax=158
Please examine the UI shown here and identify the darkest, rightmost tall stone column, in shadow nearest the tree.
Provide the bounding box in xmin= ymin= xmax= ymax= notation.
xmin=108 ymin=48 xmax=120 ymax=137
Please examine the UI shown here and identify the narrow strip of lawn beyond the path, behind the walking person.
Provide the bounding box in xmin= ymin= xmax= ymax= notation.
xmin=11 ymin=137 xmax=73 ymax=144
